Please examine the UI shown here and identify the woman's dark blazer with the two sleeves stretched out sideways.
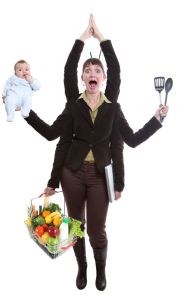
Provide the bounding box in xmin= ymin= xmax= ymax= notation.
xmin=26 ymin=100 xmax=161 ymax=172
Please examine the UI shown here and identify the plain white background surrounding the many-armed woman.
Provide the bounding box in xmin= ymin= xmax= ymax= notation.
xmin=0 ymin=0 xmax=185 ymax=300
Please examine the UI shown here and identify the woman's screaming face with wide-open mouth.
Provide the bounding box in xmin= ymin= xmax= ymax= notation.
xmin=82 ymin=64 xmax=105 ymax=94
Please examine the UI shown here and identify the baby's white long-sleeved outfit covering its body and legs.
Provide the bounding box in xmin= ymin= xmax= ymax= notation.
xmin=2 ymin=75 xmax=40 ymax=122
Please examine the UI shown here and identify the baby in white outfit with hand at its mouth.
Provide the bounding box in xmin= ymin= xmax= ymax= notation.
xmin=2 ymin=60 xmax=40 ymax=122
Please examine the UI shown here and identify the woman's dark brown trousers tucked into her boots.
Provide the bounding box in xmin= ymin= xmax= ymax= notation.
xmin=61 ymin=162 xmax=109 ymax=248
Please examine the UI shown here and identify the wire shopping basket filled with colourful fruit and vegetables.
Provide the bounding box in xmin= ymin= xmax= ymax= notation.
xmin=26 ymin=198 xmax=84 ymax=258
